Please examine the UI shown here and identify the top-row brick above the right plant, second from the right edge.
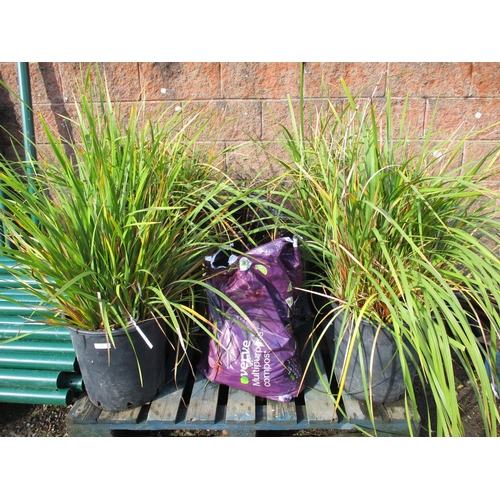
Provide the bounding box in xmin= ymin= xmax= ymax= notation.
xmin=387 ymin=62 xmax=472 ymax=97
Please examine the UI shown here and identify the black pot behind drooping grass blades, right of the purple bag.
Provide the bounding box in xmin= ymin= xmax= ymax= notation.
xmin=330 ymin=313 xmax=416 ymax=403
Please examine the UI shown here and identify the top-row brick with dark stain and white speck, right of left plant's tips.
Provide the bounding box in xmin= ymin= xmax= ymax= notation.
xmin=139 ymin=62 xmax=221 ymax=100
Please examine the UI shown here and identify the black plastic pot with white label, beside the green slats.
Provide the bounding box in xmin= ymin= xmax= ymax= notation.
xmin=69 ymin=320 xmax=167 ymax=411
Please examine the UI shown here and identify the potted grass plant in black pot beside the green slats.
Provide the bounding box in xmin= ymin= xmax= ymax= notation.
xmin=0 ymin=65 xmax=252 ymax=411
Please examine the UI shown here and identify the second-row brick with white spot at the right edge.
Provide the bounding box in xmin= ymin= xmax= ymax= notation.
xmin=425 ymin=98 xmax=500 ymax=141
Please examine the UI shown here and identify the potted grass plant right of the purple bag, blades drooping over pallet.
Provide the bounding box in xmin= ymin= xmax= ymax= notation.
xmin=268 ymin=65 xmax=500 ymax=436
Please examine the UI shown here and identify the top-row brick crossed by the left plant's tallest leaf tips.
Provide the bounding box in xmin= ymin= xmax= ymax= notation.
xmin=59 ymin=62 xmax=141 ymax=101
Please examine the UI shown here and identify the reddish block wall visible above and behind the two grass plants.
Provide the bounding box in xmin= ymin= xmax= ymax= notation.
xmin=0 ymin=62 xmax=500 ymax=179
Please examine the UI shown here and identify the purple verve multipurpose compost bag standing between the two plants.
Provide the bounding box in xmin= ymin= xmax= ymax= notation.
xmin=198 ymin=237 xmax=302 ymax=402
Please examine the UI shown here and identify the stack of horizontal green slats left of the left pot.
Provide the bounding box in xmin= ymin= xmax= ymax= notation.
xmin=0 ymin=257 xmax=79 ymax=405
